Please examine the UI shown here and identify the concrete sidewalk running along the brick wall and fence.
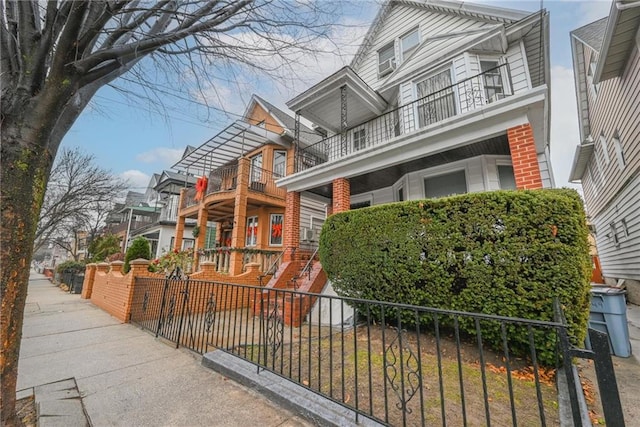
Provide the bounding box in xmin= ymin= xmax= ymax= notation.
xmin=18 ymin=272 xmax=309 ymax=427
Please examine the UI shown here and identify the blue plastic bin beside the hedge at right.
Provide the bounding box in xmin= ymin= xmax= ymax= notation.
xmin=589 ymin=286 xmax=631 ymax=357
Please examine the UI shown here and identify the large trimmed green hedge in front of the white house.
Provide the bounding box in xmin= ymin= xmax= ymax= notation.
xmin=320 ymin=189 xmax=591 ymax=364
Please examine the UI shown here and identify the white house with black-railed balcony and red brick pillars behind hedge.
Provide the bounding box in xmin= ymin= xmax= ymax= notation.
xmin=278 ymin=0 xmax=554 ymax=212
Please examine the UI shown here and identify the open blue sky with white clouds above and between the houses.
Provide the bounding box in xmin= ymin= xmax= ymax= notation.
xmin=62 ymin=0 xmax=611 ymax=192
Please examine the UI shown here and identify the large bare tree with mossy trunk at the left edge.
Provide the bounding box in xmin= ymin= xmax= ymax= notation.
xmin=0 ymin=0 xmax=339 ymax=425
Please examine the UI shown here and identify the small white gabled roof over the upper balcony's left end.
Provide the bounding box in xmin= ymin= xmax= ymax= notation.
xmin=287 ymin=66 xmax=387 ymax=133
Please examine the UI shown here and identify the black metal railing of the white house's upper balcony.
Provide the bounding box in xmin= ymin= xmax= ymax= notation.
xmin=296 ymin=64 xmax=513 ymax=172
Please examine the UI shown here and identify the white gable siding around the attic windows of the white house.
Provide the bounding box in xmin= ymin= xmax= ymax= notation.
xmin=354 ymin=5 xmax=492 ymax=89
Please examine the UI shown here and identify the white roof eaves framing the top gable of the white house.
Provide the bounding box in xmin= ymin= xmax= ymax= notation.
xmin=351 ymin=0 xmax=530 ymax=69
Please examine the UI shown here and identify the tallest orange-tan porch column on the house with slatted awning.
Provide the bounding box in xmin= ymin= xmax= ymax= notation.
xmin=229 ymin=157 xmax=250 ymax=276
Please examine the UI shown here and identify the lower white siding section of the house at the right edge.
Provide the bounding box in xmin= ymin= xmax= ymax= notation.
xmin=593 ymin=174 xmax=640 ymax=280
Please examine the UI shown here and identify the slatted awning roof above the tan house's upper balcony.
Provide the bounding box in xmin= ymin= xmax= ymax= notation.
xmin=171 ymin=120 xmax=280 ymax=174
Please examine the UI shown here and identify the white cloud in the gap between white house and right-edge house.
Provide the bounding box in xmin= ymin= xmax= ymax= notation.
xmin=551 ymin=66 xmax=580 ymax=188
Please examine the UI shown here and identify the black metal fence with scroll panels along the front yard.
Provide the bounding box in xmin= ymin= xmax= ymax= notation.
xmin=131 ymin=278 xmax=619 ymax=426
